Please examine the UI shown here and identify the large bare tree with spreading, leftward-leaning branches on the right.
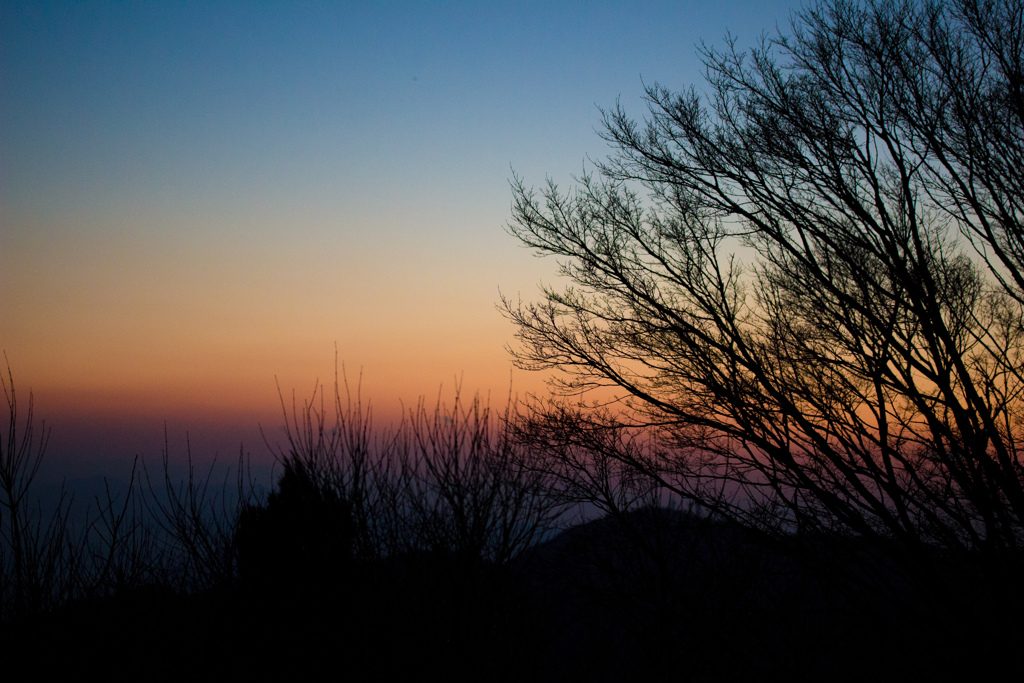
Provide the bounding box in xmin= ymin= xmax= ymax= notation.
xmin=503 ymin=0 xmax=1024 ymax=655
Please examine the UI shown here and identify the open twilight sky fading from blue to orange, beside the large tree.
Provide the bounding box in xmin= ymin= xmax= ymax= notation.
xmin=0 ymin=0 xmax=799 ymax=481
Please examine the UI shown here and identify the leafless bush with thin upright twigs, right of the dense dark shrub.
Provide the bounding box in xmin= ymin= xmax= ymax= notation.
xmin=264 ymin=358 xmax=563 ymax=564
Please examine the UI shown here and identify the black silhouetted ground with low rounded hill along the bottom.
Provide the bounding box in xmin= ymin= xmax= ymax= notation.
xmin=2 ymin=509 xmax=1022 ymax=681
